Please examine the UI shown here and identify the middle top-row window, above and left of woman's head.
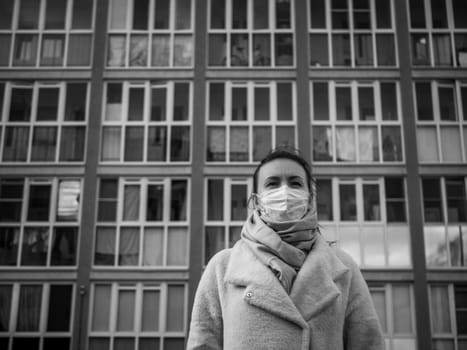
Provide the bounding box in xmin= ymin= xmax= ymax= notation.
xmin=208 ymin=0 xmax=295 ymax=68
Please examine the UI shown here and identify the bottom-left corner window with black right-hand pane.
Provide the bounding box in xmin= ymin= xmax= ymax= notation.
xmin=0 ymin=282 xmax=75 ymax=350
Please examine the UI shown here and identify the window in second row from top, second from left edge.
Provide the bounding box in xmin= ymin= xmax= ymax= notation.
xmin=101 ymin=82 xmax=192 ymax=162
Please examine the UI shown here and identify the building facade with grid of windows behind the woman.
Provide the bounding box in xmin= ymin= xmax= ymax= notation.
xmin=0 ymin=0 xmax=467 ymax=350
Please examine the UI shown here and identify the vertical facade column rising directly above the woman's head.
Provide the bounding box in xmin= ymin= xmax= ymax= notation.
xmin=292 ymin=1 xmax=311 ymax=160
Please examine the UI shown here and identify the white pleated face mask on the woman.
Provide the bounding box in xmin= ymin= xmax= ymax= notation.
xmin=258 ymin=185 xmax=310 ymax=222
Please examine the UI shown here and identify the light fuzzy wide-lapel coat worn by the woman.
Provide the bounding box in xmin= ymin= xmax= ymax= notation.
xmin=187 ymin=236 xmax=384 ymax=350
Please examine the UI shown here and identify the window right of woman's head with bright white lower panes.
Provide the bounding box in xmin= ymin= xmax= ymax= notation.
xmin=316 ymin=177 xmax=412 ymax=268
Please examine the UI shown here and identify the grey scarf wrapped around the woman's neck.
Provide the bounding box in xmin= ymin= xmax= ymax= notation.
xmin=241 ymin=210 xmax=318 ymax=293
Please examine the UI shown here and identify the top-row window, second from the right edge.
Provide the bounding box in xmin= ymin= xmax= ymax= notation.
xmin=308 ymin=0 xmax=397 ymax=68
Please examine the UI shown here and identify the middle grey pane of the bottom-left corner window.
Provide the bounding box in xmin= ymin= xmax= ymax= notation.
xmin=16 ymin=285 xmax=42 ymax=330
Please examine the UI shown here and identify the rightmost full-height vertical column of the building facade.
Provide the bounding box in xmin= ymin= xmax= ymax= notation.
xmin=394 ymin=0 xmax=431 ymax=349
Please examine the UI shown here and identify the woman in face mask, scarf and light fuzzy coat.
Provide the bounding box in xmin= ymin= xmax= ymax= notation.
xmin=187 ymin=149 xmax=384 ymax=350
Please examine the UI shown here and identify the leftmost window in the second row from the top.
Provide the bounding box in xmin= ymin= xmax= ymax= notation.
xmin=0 ymin=82 xmax=88 ymax=163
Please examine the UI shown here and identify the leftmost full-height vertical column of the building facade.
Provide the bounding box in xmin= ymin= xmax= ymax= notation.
xmin=72 ymin=0 xmax=109 ymax=350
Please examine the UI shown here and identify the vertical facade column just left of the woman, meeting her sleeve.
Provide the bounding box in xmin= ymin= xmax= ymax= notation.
xmin=188 ymin=0 xmax=207 ymax=340
